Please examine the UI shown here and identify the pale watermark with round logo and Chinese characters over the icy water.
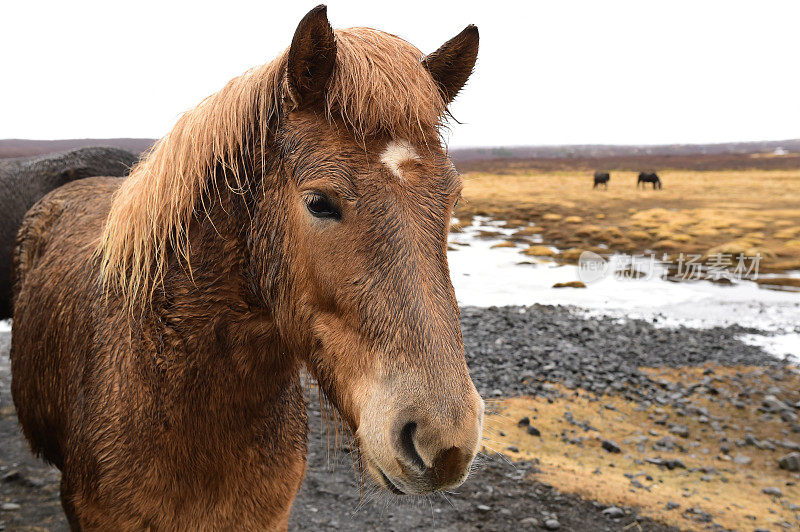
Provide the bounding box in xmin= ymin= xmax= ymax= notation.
xmin=578 ymin=251 xmax=761 ymax=284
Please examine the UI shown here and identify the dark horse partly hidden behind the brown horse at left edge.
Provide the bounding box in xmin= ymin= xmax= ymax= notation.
xmin=0 ymin=148 xmax=139 ymax=319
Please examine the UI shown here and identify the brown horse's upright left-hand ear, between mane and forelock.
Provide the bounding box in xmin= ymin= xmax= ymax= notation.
xmin=286 ymin=5 xmax=336 ymax=109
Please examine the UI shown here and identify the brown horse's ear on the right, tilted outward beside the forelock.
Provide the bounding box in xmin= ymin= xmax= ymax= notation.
xmin=422 ymin=24 xmax=478 ymax=104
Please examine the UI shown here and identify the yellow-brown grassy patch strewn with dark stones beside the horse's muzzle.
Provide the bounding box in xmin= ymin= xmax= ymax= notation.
xmin=486 ymin=365 xmax=800 ymax=530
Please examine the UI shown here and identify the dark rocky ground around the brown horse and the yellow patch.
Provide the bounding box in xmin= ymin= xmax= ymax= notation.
xmin=0 ymin=306 xmax=800 ymax=531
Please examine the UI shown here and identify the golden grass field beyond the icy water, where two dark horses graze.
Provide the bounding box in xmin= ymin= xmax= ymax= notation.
xmin=456 ymin=162 xmax=800 ymax=271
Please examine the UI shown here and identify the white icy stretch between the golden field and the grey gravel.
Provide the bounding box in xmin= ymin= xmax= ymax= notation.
xmin=448 ymin=217 xmax=800 ymax=342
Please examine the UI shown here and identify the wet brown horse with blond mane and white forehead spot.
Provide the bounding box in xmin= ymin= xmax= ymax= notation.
xmin=11 ymin=6 xmax=484 ymax=530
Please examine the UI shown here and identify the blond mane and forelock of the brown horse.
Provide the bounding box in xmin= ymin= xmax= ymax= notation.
xmin=98 ymin=28 xmax=446 ymax=308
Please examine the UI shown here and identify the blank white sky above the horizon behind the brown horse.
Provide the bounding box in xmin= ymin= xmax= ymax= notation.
xmin=0 ymin=0 xmax=800 ymax=146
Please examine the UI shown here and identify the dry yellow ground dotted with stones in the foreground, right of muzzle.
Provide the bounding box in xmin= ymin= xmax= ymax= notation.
xmin=486 ymin=367 xmax=800 ymax=530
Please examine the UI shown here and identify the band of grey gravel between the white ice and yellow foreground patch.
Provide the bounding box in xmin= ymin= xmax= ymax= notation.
xmin=461 ymin=305 xmax=784 ymax=402
